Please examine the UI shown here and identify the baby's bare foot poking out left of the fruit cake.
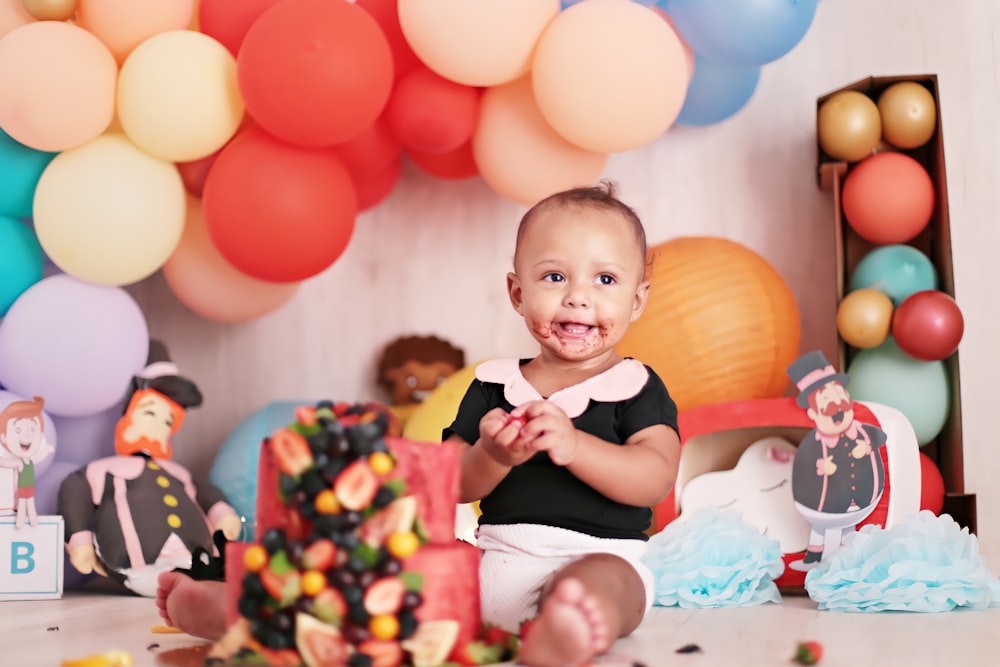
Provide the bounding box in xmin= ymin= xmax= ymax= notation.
xmin=156 ymin=572 xmax=227 ymax=640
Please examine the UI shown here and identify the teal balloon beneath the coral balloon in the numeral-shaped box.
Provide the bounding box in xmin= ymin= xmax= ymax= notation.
xmin=848 ymin=244 xmax=938 ymax=305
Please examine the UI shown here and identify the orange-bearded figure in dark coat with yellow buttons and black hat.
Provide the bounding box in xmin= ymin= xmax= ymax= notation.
xmin=59 ymin=362 xmax=242 ymax=597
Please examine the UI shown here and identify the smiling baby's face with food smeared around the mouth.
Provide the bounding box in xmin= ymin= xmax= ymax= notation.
xmin=508 ymin=207 xmax=649 ymax=361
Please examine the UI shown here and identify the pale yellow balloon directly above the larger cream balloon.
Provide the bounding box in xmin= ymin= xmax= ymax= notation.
xmin=117 ymin=30 xmax=244 ymax=162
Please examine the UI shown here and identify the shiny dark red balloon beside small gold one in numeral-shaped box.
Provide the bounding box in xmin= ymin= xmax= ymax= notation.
xmin=892 ymin=290 xmax=965 ymax=361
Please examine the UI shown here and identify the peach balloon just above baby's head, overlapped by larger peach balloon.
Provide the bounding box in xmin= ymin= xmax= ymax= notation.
xmin=472 ymin=77 xmax=607 ymax=204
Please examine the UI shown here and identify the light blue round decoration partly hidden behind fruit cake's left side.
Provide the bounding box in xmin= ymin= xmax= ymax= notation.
xmin=208 ymin=401 xmax=304 ymax=541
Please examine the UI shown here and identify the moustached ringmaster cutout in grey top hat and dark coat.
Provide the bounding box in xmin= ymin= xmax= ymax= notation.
xmin=788 ymin=352 xmax=886 ymax=571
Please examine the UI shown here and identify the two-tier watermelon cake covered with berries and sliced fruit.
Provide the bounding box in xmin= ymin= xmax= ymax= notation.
xmin=205 ymin=401 xmax=517 ymax=667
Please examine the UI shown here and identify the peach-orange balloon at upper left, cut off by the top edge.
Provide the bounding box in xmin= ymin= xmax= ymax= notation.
xmin=76 ymin=0 xmax=195 ymax=64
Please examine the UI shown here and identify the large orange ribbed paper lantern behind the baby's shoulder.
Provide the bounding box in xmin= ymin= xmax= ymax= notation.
xmin=618 ymin=237 xmax=800 ymax=411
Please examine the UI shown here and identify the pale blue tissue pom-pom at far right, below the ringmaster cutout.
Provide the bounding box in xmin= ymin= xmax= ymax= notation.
xmin=805 ymin=510 xmax=1000 ymax=612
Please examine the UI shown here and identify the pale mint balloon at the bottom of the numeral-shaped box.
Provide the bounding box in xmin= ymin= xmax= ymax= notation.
xmin=847 ymin=336 xmax=951 ymax=447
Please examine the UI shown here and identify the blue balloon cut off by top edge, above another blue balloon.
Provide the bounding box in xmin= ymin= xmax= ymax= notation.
xmin=666 ymin=0 xmax=817 ymax=65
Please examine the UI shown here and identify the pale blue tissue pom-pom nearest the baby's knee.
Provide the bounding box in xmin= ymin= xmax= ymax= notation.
xmin=644 ymin=507 xmax=785 ymax=609
